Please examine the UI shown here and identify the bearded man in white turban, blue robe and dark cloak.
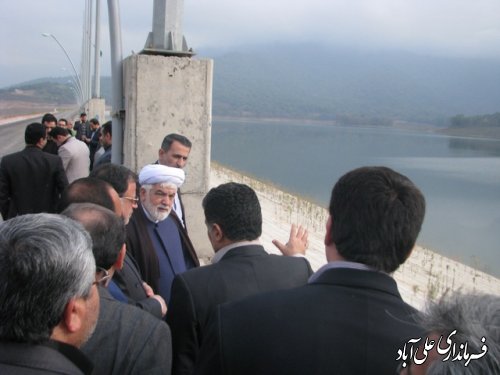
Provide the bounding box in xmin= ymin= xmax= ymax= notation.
xmin=127 ymin=164 xmax=200 ymax=304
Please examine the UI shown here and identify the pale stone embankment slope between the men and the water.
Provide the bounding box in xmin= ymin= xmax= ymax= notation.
xmin=210 ymin=163 xmax=500 ymax=308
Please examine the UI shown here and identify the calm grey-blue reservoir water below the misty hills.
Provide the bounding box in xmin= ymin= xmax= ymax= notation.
xmin=212 ymin=120 xmax=500 ymax=277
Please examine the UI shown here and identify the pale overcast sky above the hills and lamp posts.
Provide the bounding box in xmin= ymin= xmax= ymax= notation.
xmin=0 ymin=0 xmax=500 ymax=87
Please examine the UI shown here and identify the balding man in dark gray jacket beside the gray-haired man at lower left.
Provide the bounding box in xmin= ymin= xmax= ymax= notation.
xmin=63 ymin=203 xmax=172 ymax=375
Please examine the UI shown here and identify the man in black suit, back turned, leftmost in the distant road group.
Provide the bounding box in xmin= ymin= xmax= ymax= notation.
xmin=0 ymin=123 xmax=68 ymax=220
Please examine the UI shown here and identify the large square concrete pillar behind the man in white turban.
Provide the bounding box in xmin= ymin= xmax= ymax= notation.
xmin=123 ymin=55 xmax=213 ymax=258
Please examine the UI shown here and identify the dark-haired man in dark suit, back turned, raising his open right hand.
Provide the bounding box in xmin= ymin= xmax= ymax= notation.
xmin=167 ymin=183 xmax=312 ymax=374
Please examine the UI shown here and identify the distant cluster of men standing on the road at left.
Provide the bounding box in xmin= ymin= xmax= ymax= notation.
xmin=0 ymin=113 xmax=111 ymax=220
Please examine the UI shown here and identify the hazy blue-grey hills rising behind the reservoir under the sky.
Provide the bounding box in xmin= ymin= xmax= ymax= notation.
xmin=0 ymin=44 xmax=500 ymax=126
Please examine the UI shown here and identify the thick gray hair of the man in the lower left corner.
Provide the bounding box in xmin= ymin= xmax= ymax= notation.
xmin=0 ymin=214 xmax=96 ymax=343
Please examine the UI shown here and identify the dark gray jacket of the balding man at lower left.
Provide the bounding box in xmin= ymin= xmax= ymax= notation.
xmin=81 ymin=287 xmax=172 ymax=375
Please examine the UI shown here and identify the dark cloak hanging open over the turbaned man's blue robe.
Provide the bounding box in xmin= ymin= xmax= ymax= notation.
xmin=127 ymin=203 xmax=200 ymax=292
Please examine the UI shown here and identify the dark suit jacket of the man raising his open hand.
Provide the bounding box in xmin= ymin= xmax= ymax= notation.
xmin=167 ymin=245 xmax=312 ymax=374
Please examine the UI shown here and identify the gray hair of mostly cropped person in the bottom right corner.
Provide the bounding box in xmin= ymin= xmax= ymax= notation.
xmin=421 ymin=292 xmax=500 ymax=375
